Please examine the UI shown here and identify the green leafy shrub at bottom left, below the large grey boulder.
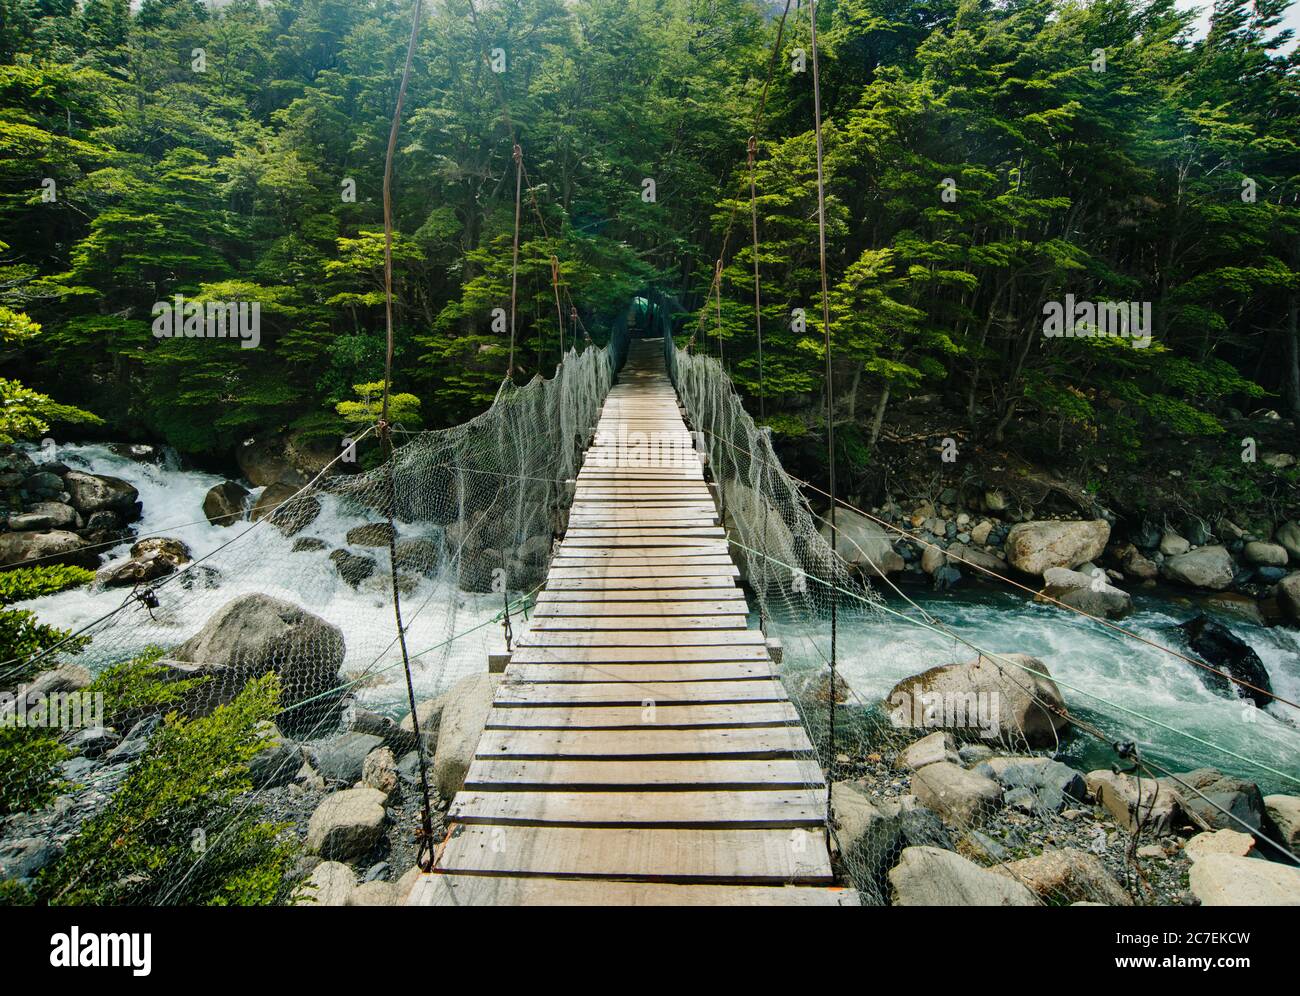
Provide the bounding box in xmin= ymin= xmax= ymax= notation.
xmin=39 ymin=675 xmax=296 ymax=906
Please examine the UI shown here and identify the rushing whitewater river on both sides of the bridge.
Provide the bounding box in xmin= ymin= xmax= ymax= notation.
xmin=12 ymin=445 xmax=1300 ymax=792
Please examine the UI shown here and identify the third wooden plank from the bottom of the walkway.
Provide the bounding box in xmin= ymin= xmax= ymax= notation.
xmin=447 ymin=789 xmax=826 ymax=830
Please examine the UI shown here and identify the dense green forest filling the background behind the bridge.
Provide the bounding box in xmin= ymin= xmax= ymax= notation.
xmin=0 ymin=0 xmax=1300 ymax=514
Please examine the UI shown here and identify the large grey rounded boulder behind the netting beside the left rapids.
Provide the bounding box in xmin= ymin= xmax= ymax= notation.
xmin=170 ymin=594 xmax=345 ymax=733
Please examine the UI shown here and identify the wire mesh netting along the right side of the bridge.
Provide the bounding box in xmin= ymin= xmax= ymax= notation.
xmin=664 ymin=301 xmax=1300 ymax=905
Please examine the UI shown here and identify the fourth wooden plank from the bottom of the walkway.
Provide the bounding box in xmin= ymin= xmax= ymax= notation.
xmin=465 ymin=758 xmax=826 ymax=792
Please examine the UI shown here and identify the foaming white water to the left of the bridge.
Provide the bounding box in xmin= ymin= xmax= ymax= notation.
xmin=11 ymin=443 xmax=503 ymax=713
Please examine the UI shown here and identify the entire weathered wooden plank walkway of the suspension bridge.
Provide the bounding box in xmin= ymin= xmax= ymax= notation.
xmin=411 ymin=339 xmax=857 ymax=906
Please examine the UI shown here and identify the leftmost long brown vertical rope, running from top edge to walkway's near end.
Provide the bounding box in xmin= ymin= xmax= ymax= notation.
xmin=378 ymin=0 xmax=433 ymax=871
